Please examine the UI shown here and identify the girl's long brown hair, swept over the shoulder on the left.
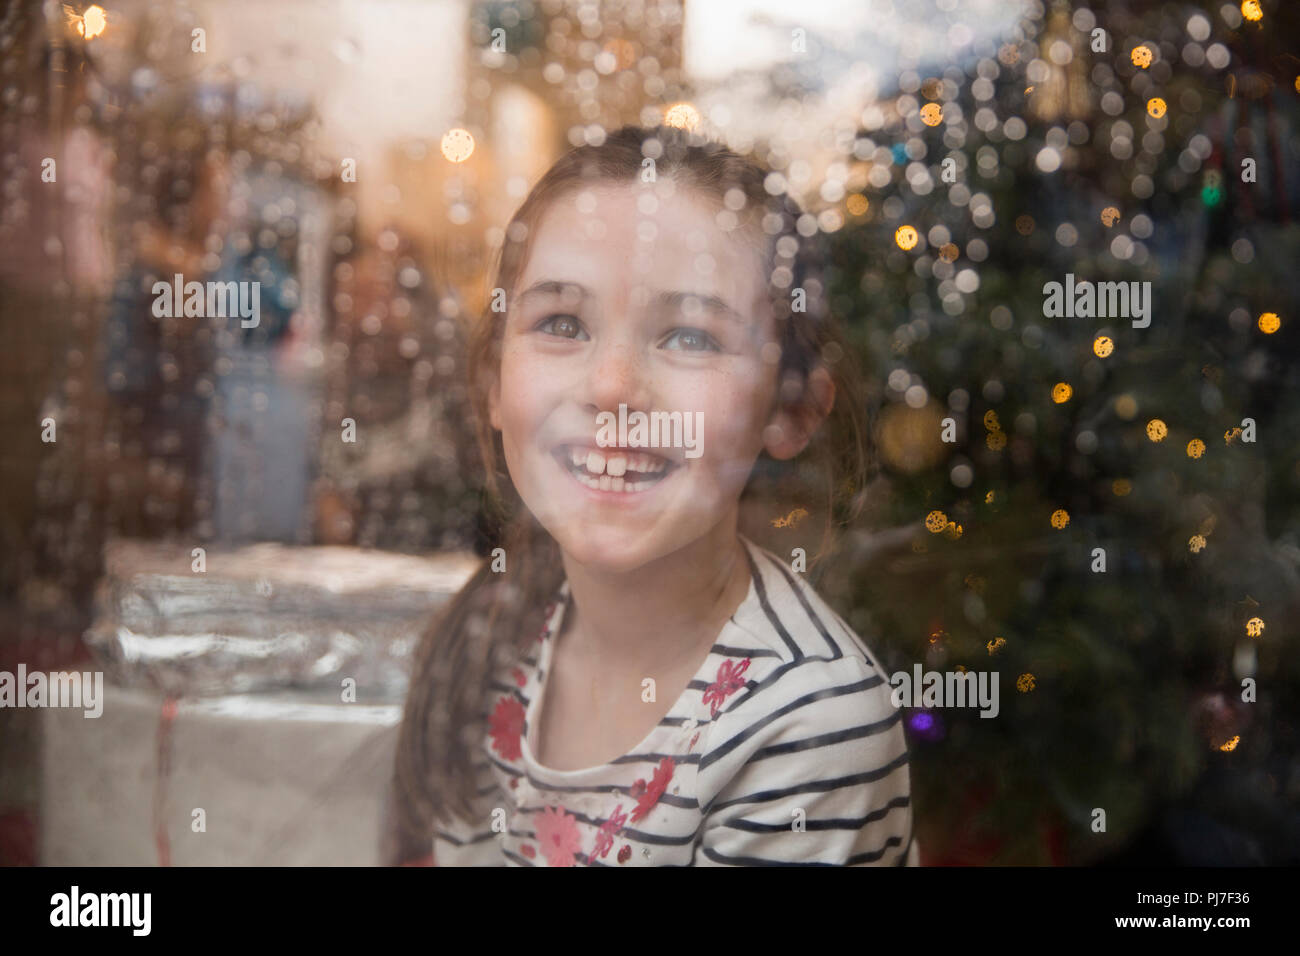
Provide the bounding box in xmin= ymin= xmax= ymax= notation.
xmin=394 ymin=126 xmax=867 ymax=852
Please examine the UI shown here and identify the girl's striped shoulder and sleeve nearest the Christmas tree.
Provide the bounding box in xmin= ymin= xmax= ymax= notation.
xmin=696 ymin=541 xmax=911 ymax=864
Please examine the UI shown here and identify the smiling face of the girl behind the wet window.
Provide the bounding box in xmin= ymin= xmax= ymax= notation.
xmin=490 ymin=183 xmax=803 ymax=571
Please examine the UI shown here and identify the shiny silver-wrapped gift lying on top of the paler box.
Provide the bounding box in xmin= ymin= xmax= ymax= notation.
xmin=86 ymin=540 xmax=478 ymax=702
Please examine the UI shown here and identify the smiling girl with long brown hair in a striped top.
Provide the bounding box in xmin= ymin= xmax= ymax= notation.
xmin=397 ymin=126 xmax=918 ymax=866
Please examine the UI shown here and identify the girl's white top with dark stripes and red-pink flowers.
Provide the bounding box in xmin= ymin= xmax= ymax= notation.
xmin=433 ymin=537 xmax=919 ymax=866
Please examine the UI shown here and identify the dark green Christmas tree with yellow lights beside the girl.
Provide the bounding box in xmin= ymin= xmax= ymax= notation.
xmin=824 ymin=3 xmax=1300 ymax=864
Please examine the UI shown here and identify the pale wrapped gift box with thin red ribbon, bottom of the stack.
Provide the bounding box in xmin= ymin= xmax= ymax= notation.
xmin=39 ymin=685 xmax=402 ymax=866
